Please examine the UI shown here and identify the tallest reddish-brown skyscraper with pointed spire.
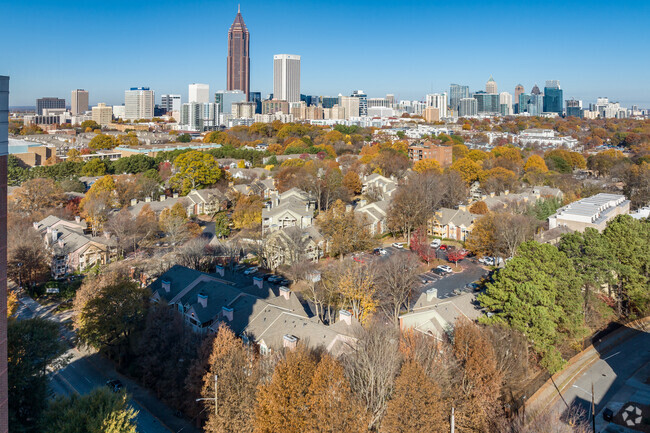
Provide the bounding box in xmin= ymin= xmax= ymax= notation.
xmin=226 ymin=6 xmax=251 ymax=100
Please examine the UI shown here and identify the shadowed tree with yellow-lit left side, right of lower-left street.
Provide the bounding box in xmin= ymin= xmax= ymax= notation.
xmin=75 ymin=279 xmax=150 ymax=362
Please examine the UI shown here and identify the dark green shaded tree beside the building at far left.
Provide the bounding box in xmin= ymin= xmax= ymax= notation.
xmin=7 ymin=318 xmax=66 ymax=432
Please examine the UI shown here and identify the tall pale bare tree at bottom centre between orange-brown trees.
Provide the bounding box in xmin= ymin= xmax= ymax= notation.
xmin=342 ymin=323 xmax=402 ymax=429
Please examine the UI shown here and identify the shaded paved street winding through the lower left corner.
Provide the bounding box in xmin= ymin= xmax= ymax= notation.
xmin=16 ymin=296 xmax=197 ymax=433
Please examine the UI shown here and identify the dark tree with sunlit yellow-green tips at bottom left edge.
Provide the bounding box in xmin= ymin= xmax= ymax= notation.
xmin=42 ymin=388 xmax=138 ymax=433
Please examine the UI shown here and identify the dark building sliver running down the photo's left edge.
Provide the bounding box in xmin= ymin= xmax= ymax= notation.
xmin=0 ymin=76 xmax=9 ymax=433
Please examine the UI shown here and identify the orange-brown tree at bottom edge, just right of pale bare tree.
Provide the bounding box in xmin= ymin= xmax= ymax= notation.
xmin=380 ymin=361 xmax=449 ymax=433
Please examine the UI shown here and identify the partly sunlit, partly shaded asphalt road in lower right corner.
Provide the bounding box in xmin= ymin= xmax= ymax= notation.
xmin=555 ymin=331 xmax=650 ymax=422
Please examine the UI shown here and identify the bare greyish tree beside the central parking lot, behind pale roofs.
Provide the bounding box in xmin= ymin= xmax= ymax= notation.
xmin=377 ymin=254 xmax=419 ymax=326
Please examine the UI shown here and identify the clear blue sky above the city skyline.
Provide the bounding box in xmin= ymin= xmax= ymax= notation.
xmin=0 ymin=0 xmax=650 ymax=107
